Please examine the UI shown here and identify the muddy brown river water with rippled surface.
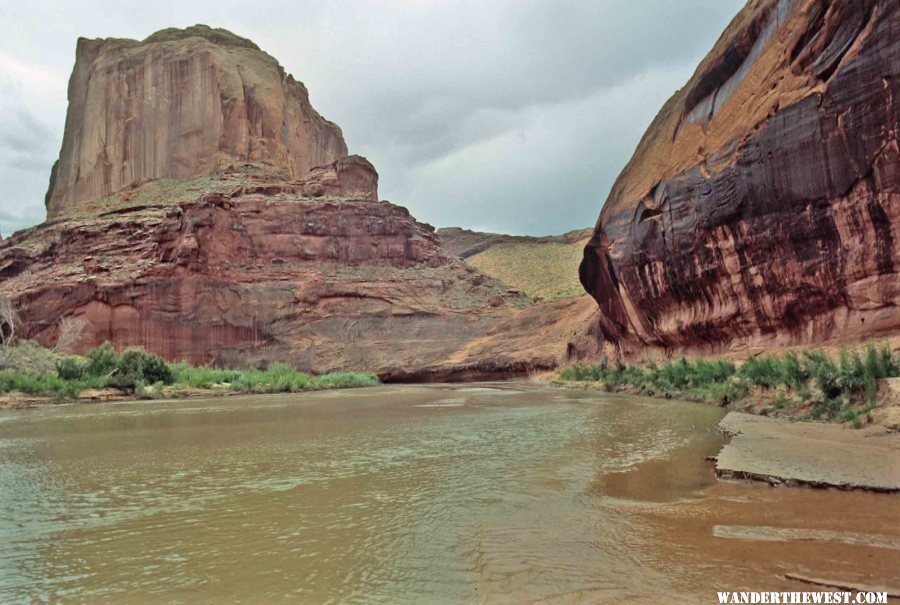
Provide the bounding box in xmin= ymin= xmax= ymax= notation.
xmin=0 ymin=383 xmax=900 ymax=604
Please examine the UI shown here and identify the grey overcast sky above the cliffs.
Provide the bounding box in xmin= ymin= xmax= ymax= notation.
xmin=0 ymin=0 xmax=744 ymax=236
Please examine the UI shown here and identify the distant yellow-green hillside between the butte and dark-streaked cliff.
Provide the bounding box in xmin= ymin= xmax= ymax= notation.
xmin=437 ymin=227 xmax=591 ymax=301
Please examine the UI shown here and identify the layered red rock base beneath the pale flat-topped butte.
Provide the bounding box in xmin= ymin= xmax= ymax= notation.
xmin=0 ymin=165 xmax=593 ymax=380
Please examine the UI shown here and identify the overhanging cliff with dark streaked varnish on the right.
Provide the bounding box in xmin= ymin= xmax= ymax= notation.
xmin=580 ymin=0 xmax=900 ymax=355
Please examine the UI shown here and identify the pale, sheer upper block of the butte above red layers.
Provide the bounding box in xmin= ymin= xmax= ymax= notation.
xmin=46 ymin=25 xmax=347 ymax=218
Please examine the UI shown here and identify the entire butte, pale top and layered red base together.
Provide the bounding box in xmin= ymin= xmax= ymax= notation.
xmin=0 ymin=26 xmax=594 ymax=380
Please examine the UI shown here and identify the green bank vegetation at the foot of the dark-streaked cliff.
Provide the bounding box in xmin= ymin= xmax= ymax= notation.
xmin=560 ymin=344 xmax=900 ymax=426
